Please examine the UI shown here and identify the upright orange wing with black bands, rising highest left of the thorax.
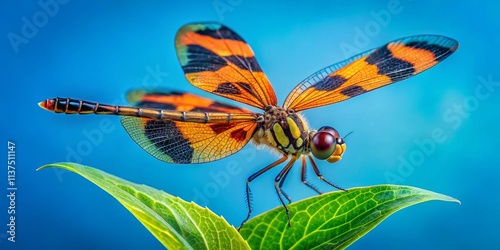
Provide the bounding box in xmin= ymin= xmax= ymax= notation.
xmin=175 ymin=23 xmax=277 ymax=109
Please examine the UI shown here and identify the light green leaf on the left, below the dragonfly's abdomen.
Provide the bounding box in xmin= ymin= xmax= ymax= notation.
xmin=39 ymin=163 xmax=250 ymax=249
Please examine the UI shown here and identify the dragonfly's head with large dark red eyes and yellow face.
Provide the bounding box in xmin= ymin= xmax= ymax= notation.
xmin=309 ymin=126 xmax=346 ymax=163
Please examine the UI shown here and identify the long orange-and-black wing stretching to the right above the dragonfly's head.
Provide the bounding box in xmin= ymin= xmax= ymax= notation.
xmin=283 ymin=35 xmax=458 ymax=111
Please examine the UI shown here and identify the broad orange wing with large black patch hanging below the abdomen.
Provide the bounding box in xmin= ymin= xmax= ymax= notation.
xmin=121 ymin=116 xmax=257 ymax=164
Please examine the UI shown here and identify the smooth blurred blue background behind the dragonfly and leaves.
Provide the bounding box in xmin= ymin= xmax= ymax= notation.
xmin=0 ymin=0 xmax=500 ymax=249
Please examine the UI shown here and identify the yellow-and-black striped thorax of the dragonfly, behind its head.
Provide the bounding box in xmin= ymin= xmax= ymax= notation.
xmin=253 ymin=105 xmax=309 ymax=155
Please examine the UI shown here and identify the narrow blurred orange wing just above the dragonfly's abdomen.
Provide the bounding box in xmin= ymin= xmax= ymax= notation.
xmin=127 ymin=90 xmax=253 ymax=114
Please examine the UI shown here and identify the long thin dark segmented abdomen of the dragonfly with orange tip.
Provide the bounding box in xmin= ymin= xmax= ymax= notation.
xmin=38 ymin=98 xmax=257 ymax=123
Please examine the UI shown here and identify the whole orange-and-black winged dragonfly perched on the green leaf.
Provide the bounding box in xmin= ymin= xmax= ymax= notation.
xmin=39 ymin=22 xmax=458 ymax=228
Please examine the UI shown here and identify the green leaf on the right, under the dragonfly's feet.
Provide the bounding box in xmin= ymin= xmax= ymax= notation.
xmin=240 ymin=185 xmax=460 ymax=249
